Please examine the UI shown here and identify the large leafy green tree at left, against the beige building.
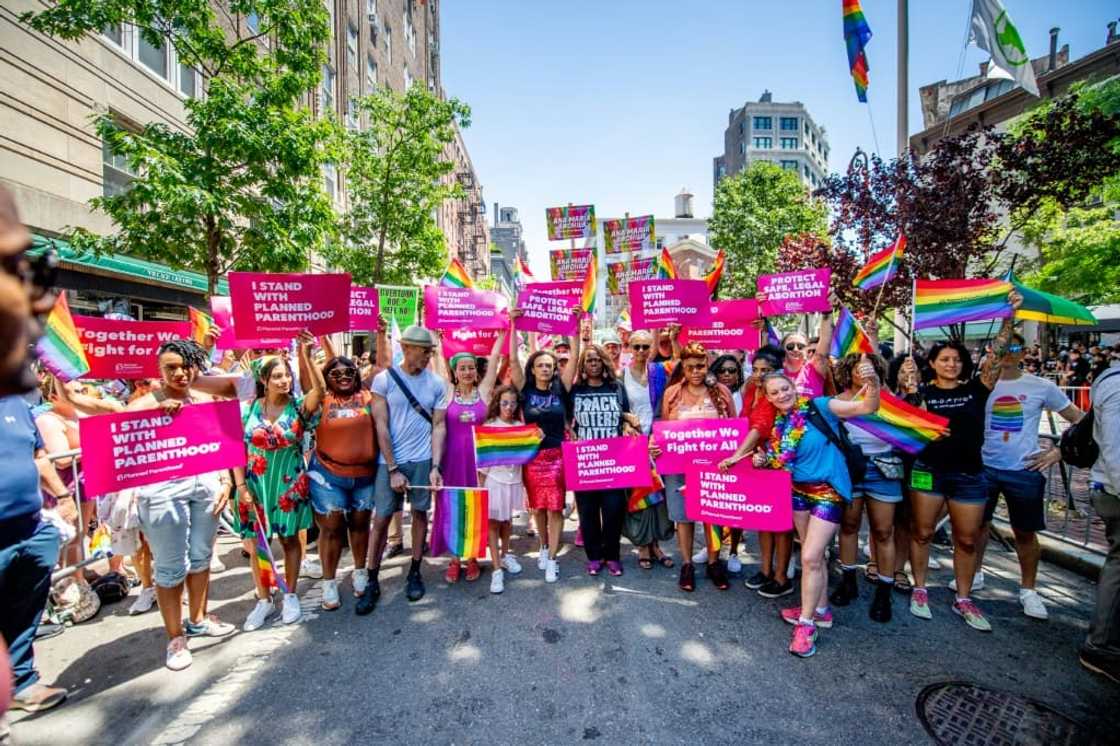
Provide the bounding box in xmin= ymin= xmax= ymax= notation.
xmin=21 ymin=0 xmax=336 ymax=295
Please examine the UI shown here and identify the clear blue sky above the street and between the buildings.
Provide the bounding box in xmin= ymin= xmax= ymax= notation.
xmin=440 ymin=0 xmax=1120 ymax=273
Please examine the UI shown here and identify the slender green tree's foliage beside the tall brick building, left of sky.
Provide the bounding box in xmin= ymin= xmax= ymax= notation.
xmin=326 ymin=86 xmax=470 ymax=283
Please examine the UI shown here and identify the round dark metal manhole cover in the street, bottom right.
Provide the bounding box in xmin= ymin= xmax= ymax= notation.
xmin=917 ymin=681 xmax=1096 ymax=746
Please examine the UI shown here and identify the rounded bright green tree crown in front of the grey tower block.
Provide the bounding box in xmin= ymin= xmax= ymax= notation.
xmin=708 ymin=161 xmax=828 ymax=298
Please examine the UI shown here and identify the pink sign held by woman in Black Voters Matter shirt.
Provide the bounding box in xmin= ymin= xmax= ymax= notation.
xmin=562 ymin=437 xmax=653 ymax=491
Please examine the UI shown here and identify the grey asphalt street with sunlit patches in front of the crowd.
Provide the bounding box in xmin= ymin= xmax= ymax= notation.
xmin=6 ymin=522 xmax=1120 ymax=746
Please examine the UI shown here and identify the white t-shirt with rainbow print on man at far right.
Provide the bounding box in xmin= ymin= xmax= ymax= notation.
xmin=983 ymin=373 xmax=1070 ymax=469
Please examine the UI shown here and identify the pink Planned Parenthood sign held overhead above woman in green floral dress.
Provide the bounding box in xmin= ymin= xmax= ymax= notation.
xmin=230 ymin=272 xmax=351 ymax=338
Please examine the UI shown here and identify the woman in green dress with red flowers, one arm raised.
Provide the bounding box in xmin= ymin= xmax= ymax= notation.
xmin=234 ymin=333 xmax=324 ymax=632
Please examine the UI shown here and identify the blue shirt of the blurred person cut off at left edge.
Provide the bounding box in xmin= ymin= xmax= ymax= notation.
xmin=0 ymin=395 xmax=43 ymax=521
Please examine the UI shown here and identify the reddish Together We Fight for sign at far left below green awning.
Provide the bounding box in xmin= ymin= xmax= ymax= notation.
xmin=74 ymin=314 xmax=190 ymax=378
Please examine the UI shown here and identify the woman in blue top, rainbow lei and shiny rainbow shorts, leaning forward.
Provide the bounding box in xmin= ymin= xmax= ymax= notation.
xmin=753 ymin=358 xmax=879 ymax=658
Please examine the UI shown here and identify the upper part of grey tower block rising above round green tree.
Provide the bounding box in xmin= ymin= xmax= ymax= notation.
xmin=712 ymin=91 xmax=829 ymax=188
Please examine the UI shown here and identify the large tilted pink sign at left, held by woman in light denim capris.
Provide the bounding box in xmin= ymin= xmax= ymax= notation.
xmin=78 ymin=400 xmax=245 ymax=496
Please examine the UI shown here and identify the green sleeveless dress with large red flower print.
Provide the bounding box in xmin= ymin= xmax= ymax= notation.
xmin=234 ymin=397 xmax=318 ymax=539
